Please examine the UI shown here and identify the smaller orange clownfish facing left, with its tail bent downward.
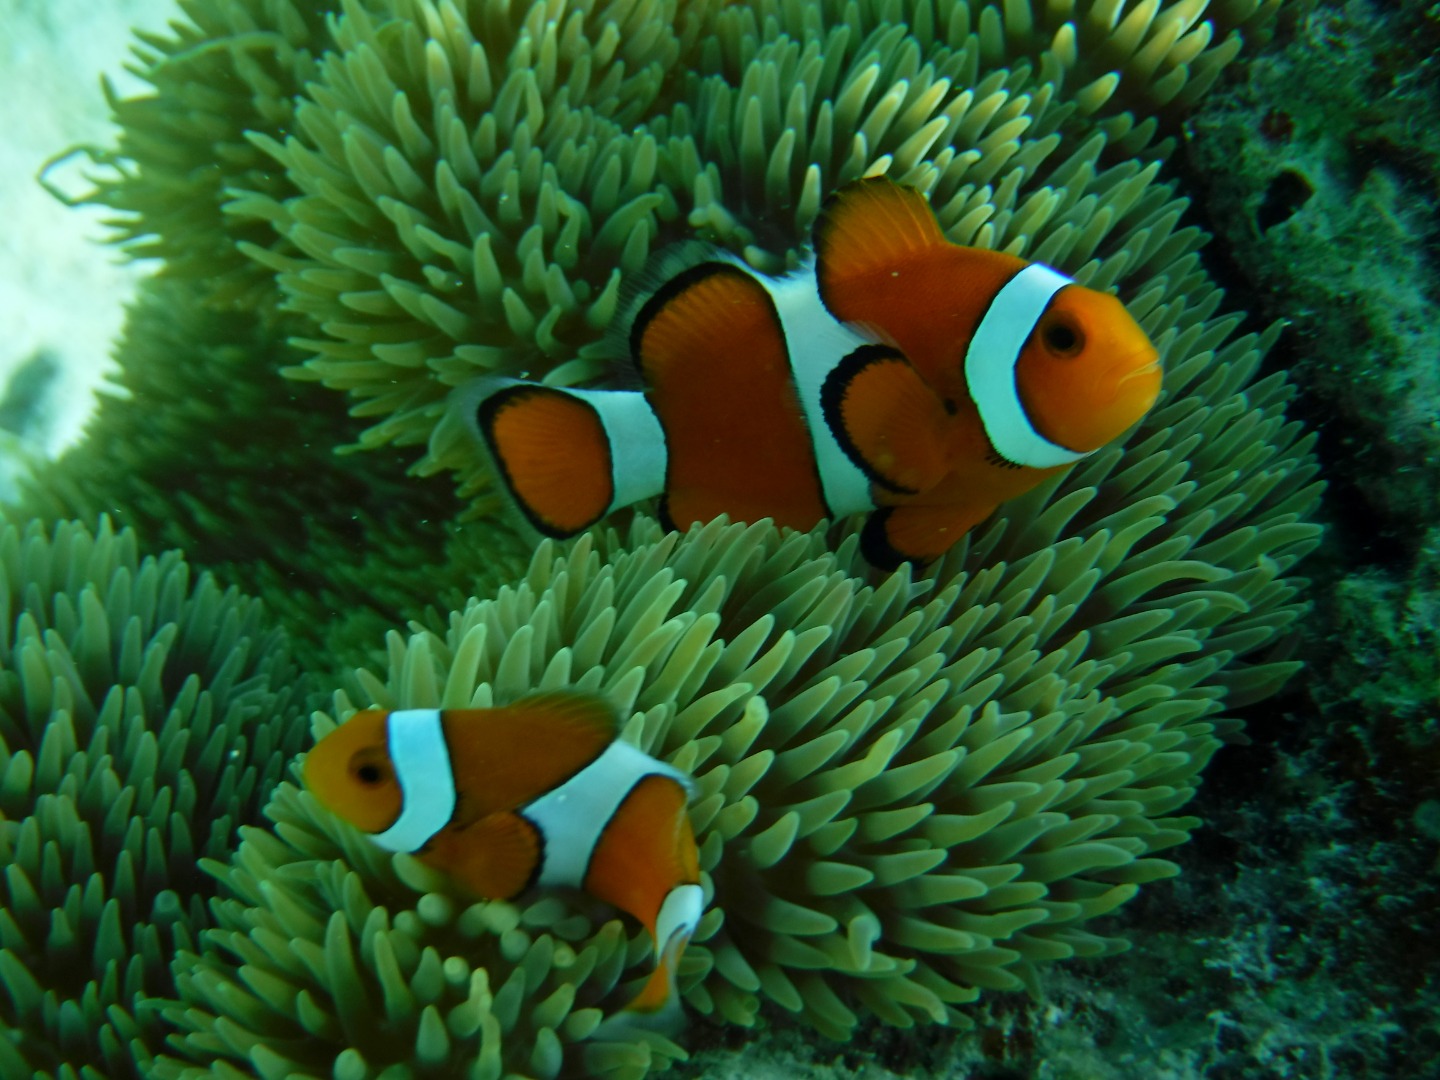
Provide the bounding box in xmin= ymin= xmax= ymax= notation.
xmin=304 ymin=691 xmax=704 ymax=1017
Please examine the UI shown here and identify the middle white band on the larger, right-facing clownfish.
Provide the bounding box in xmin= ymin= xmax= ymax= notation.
xmin=747 ymin=261 xmax=876 ymax=517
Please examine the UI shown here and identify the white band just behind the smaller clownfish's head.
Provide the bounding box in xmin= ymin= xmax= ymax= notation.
xmin=374 ymin=708 xmax=455 ymax=851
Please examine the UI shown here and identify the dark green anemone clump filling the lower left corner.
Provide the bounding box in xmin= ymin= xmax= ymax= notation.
xmin=0 ymin=520 xmax=305 ymax=1077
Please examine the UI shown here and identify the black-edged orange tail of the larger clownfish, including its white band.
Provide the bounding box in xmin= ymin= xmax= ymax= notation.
xmin=455 ymin=377 xmax=665 ymax=539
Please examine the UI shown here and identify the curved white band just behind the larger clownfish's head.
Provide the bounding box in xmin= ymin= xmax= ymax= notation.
xmin=965 ymin=262 xmax=1089 ymax=469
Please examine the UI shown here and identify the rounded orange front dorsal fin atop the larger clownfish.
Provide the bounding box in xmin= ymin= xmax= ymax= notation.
xmin=814 ymin=176 xmax=949 ymax=285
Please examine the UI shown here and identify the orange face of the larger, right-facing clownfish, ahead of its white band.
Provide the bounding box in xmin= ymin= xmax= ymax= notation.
xmin=1015 ymin=285 xmax=1162 ymax=454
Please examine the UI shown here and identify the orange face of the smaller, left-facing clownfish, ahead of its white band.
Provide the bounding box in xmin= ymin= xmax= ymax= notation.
xmin=302 ymin=708 xmax=405 ymax=832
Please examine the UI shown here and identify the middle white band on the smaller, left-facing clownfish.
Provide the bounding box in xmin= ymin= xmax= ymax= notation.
xmin=520 ymin=739 xmax=690 ymax=887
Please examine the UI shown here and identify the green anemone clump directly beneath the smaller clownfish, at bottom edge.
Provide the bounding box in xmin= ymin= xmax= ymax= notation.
xmin=150 ymin=783 xmax=684 ymax=1080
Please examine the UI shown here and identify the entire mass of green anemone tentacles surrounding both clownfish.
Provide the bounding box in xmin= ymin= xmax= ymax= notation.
xmin=0 ymin=0 xmax=1319 ymax=1079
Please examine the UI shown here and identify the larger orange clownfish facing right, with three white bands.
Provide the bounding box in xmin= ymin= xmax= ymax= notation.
xmin=455 ymin=177 xmax=1161 ymax=569
